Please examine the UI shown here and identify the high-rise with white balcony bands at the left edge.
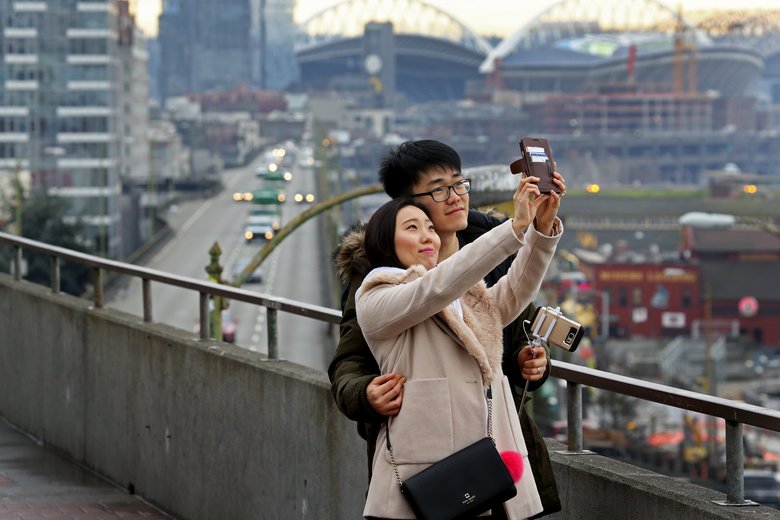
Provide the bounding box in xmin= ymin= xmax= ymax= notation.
xmin=0 ymin=0 xmax=146 ymax=257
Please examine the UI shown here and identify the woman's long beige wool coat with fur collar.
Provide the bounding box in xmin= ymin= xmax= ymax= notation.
xmin=356 ymin=217 xmax=563 ymax=519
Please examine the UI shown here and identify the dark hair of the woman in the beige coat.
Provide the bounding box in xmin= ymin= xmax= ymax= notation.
xmin=364 ymin=197 xmax=431 ymax=269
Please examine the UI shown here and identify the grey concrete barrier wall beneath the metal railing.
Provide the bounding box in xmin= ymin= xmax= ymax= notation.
xmin=0 ymin=274 xmax=780 ymax=520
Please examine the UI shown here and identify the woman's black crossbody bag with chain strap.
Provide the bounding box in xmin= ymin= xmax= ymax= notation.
xmin=387 ymin=387 xmax=517 ymax=520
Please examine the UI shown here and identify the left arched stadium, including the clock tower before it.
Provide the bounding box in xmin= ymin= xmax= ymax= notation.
xmin=295 ymin=0 xmax=491 ymax=108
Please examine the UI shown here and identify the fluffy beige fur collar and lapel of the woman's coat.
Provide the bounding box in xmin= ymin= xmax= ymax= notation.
xmin=361 ymin=265 xmax=503 ymax=384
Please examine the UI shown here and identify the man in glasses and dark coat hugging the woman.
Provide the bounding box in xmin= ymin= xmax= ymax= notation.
xmin=328 ymin=140 xmax=565 ymax=516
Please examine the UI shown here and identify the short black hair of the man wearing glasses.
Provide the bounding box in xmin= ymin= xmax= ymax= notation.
xmin=379 ymin=139 xmax=460 ymax=198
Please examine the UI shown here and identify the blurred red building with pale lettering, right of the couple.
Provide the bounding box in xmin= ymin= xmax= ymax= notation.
xmin=579 ymin=227 xmax=780 ymax=348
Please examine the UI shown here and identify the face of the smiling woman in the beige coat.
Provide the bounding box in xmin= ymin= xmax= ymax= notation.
xmin=395 ymin=206 xmax=441 ymax=269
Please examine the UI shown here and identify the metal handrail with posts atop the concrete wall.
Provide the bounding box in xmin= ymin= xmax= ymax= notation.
xmin=0 ymin=232 xmax=780 ymax=506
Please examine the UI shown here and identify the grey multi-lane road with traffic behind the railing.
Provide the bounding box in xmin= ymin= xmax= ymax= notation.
xmin=107 ymin=146 xmax=337 ymax=370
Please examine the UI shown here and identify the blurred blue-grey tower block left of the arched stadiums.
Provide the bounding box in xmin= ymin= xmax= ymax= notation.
xmin=158 ymin=0 xmax=297 ymax=100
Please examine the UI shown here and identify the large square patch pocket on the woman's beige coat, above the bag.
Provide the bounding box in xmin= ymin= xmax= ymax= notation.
xmin=387 ymin=379 xmax=453 ymax=464
